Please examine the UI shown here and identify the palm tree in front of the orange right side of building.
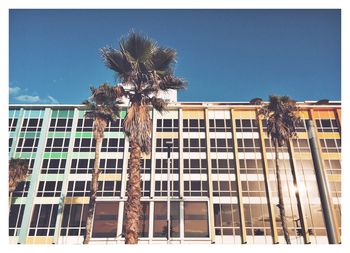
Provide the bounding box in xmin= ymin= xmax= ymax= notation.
xmin=258 ymin=95 xmax=299 ymax=244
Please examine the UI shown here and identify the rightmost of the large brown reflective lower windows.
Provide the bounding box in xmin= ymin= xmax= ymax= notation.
xmin=184 ymin=201 xmax=209 ymax=237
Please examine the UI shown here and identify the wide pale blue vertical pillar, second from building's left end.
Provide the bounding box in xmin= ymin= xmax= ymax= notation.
xmin=18 ymin=108 xmax=51 ymax=244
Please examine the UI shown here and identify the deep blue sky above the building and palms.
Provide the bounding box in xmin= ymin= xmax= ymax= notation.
xmin=9 ymin=9 xmax=341 ymax=104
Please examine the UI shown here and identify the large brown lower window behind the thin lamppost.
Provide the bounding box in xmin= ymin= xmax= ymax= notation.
xmin=153 ymin=201 xmax=180 ymax=237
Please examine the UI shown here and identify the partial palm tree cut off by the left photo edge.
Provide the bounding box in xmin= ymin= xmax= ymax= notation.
xmin=9 ymin=158 xmax=28 ymax=208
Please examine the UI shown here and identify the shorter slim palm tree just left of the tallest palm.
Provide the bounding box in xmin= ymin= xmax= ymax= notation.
xmin=83 ymin=83 xmax=119 ymax=244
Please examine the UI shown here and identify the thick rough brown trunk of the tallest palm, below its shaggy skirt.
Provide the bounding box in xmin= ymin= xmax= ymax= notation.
xmin=125 ymin=141 xmax=141 ymax=244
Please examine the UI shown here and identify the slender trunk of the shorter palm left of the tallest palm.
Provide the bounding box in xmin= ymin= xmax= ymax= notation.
xmin=83 ymin=138 xmax=102 ymax=244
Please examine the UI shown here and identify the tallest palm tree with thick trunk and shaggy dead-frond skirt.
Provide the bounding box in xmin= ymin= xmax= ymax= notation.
xmin=101 ymin=32 xmax=186 ymax=244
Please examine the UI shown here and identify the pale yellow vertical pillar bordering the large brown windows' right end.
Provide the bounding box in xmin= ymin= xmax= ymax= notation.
xmin=204 ymin=108 xmax=215 ymax=243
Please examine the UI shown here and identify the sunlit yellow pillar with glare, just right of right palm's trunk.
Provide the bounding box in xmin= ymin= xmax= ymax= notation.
xmin=287 ymin=140 xmax=311 ymax=244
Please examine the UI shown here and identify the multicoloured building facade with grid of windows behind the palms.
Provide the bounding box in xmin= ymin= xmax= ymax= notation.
xmin=9 ymin=102 xmax=341 ymax=244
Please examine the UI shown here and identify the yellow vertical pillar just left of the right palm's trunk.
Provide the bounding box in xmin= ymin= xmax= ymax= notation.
xmin=258 ymin=118 xmax=278 ymax=244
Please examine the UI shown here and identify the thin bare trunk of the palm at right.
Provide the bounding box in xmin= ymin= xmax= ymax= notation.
xmin=274 ymin=140 xmax=291 ymax=244
